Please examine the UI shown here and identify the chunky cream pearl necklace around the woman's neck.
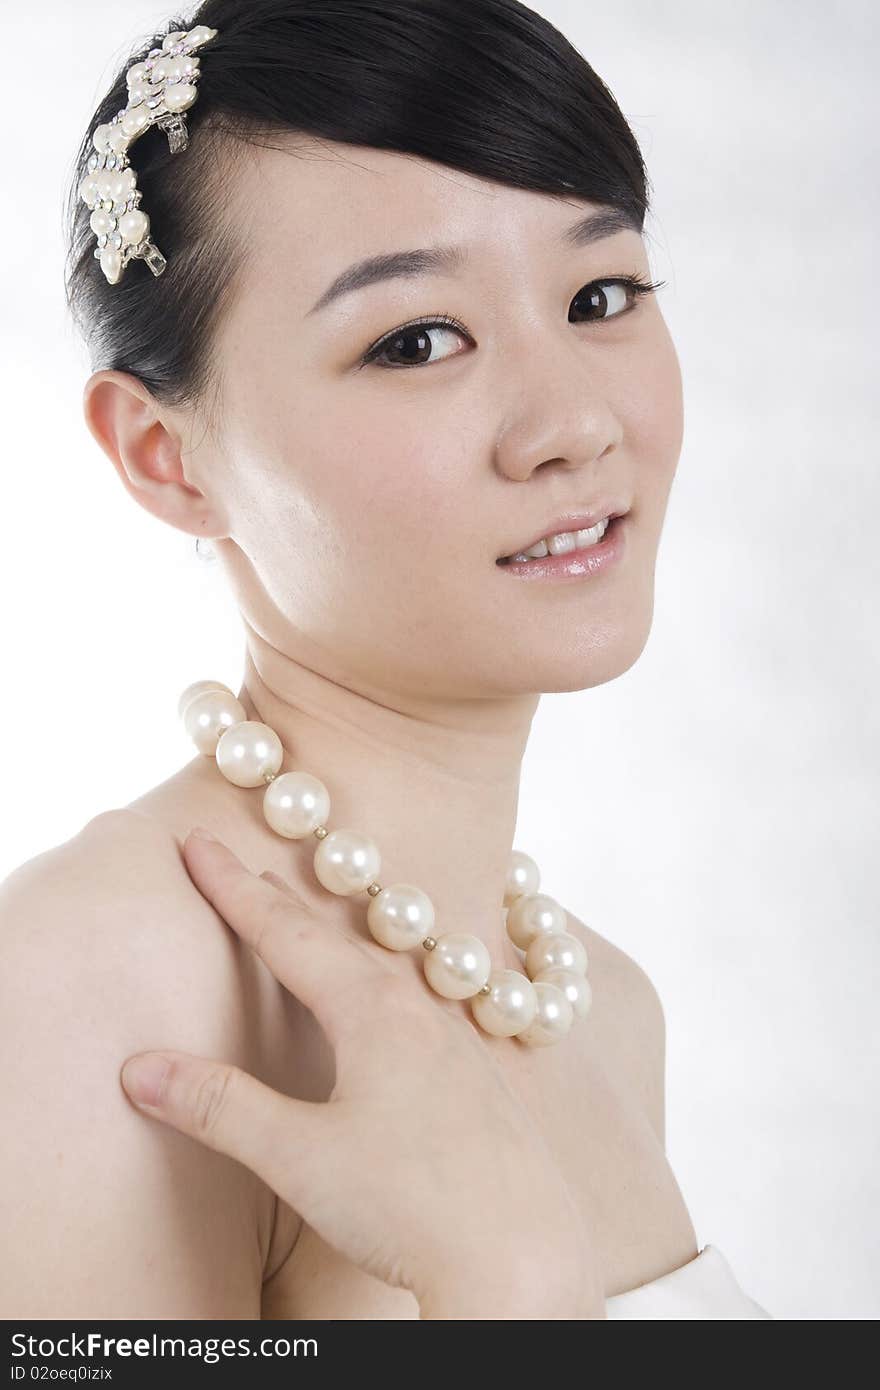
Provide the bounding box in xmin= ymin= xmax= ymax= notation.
xmin=178 ymin=681 xmax=592 ymax=1047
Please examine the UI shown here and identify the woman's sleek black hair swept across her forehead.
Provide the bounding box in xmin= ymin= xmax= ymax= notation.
xmin=65 ymin=0 xmax=648 ymax=430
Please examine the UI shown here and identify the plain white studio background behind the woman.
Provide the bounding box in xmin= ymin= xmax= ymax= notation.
xmin=0 ymin=0 xmax=880 ymax=1319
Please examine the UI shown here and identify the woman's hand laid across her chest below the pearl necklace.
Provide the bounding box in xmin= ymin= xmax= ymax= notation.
xmin=122 ymin=834 xmax=605 ymax=1318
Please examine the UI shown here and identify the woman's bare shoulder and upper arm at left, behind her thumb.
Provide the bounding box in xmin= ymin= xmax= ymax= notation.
xmin=0 ymin=808 xmax=272 ymax=1318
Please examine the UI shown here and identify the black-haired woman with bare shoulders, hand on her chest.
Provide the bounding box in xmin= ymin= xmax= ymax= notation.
xmin=3 ymin=0 xmax=766 ymax=1319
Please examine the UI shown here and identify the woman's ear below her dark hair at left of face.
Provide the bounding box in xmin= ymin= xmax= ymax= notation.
xmin=82 ymin=371 xmax=229 ymax=539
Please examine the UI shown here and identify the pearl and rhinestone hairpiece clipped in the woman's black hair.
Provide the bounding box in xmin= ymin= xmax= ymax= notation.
xmin=79 ymin=24 xmax=217 ymax=285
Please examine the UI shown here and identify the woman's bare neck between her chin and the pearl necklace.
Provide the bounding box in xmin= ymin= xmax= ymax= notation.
xmin=229 ymin=620 xmax=539 ymax=967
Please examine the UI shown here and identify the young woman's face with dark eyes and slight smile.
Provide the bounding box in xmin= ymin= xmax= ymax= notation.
xmin=192 ymin=136 xmax=683 ymax=698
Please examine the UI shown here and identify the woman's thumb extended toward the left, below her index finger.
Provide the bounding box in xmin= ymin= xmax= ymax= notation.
xmin=120 ymin=1049 xmax=324 ymax=1205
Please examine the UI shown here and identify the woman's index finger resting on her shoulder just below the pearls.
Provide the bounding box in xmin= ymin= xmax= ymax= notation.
xmin=184 ymin=834 xmax=384 ymax=1044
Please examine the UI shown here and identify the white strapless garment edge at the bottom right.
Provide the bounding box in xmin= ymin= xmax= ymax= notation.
xmin=605 ymin=1245 xmax=774 ymax=1322
